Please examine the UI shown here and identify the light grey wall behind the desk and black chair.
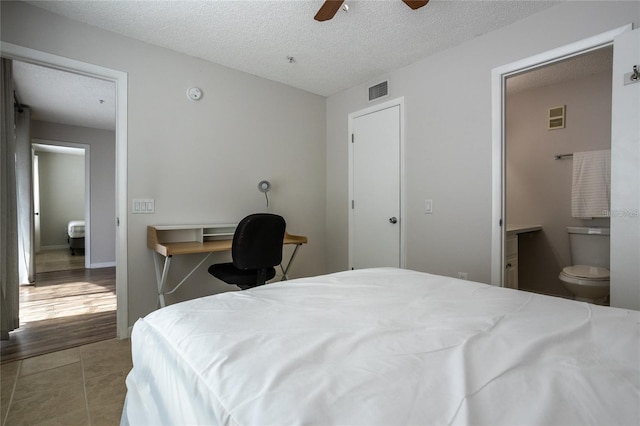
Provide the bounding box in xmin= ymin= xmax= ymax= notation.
xmin=0 ymin=2 xmax=326 ymax=323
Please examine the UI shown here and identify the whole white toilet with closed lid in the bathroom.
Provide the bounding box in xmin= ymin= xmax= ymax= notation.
xmin=558 ymin=226 xmax=609 ymax=305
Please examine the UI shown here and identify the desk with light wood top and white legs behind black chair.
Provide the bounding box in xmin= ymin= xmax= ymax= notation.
xmin=147 ymin=224 xmax=307 ymax=308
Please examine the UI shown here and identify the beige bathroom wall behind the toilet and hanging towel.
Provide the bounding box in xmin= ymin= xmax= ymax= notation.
xmin=506 ymin=71 xmax=611 ymax=296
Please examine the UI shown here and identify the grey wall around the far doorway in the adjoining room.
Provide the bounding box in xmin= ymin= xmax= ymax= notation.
xmin=31 ymin=121 xmax=116 ymax=265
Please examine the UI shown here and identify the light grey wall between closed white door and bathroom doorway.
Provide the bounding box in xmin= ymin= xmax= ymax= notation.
xmin=327 ymin=2 xmax=640 ymax=283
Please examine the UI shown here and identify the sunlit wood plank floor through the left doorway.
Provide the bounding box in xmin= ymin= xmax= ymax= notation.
xmin=0 ymin=268 xmax=116 ymax=364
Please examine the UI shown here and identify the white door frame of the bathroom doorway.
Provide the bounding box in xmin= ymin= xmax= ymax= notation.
xmin=491 ymin=24 xmax=633 ymax=287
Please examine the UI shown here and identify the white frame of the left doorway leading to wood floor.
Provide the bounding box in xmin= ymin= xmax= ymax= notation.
xmin=0 ymin=41 xmax=129 ymax=339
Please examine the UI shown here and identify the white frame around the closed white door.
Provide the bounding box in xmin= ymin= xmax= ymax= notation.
xmin=347 ymin=96 xmax=407 ymax=269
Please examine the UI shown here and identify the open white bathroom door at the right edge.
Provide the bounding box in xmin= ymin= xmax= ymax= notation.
xmin=610 ymin=30 xmax=640 ymax=310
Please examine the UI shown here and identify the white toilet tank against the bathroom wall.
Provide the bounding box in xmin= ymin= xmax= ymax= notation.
xmin=567 ymin=226 xmax=609 ymax=269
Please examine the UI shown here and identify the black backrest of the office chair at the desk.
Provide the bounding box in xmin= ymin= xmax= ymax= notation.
xmin=231 ymin=213 xmax=286 ymax=269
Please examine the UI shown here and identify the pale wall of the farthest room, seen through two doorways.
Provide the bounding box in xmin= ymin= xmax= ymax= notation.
xmin=38 ymin=152 xmax=84 ymax=250
